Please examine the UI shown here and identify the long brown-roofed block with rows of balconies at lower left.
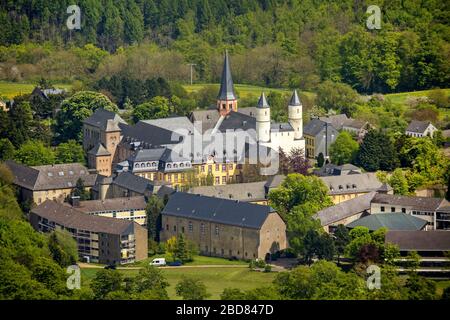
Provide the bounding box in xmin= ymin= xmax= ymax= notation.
xmin=29 ymin=200 xmax=148 ymax=264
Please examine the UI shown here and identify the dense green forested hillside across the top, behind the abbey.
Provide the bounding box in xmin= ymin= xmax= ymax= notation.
xmin=0 ymin=0 xmax=450 ymax=93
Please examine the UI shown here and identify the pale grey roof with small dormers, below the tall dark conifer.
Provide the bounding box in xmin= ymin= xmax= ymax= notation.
xmin=319 ymin=172 xmax=383 ymax=195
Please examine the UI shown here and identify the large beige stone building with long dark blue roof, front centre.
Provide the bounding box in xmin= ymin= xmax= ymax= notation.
xmin=160 ymin=192 xmax=288 ymax=259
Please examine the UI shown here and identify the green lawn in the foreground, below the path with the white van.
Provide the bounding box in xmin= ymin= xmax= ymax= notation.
xmin=81 ymin=267 xmax=276 ymax=300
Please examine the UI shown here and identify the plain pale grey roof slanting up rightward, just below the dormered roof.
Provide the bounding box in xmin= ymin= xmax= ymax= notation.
xmin=314 ymin=192 xmax=375 ymax=226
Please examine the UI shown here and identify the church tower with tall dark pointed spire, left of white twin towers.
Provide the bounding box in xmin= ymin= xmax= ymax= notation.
xmin=217 ymin=51 xmax=237 ymax=116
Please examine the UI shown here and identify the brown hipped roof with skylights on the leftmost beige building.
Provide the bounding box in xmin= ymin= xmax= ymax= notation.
xmin=6 ymin=161 xmax=97 ymax=191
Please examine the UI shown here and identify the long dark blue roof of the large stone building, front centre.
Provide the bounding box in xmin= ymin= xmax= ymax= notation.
xmin=162 ymin=192 xmax=275 ymax=229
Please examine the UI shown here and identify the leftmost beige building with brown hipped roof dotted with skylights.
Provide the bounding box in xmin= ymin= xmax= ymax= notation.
xmin=6 ymin=161 xmax=97 ymax=204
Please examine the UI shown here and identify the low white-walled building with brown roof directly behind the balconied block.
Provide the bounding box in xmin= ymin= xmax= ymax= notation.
xmin=72 ymin=196 xmax=147 ymax=226
